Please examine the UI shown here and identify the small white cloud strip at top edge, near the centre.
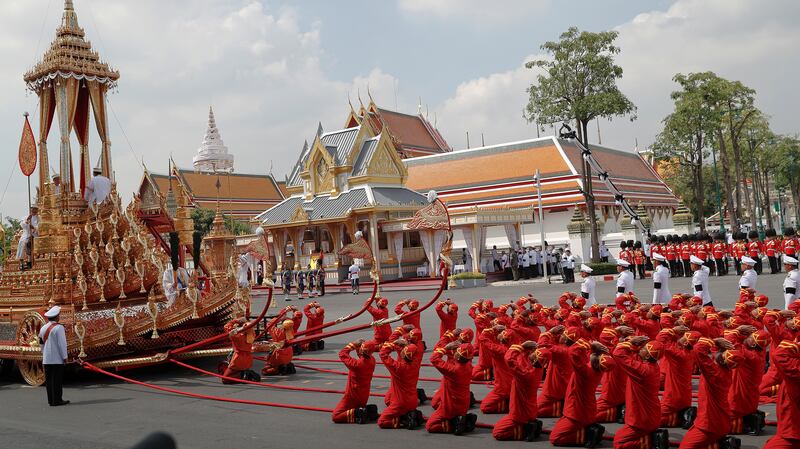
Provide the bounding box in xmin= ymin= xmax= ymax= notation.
xmin=398 ymin=0 xmax=550 ymax=24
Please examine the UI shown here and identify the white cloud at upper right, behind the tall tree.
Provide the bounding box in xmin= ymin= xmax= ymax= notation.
xmin=436 ymin=0 xmax=800 ymax=150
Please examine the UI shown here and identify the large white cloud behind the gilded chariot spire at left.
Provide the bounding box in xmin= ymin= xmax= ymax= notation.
xmin=0 ymin=0 xmax=397 ymax=215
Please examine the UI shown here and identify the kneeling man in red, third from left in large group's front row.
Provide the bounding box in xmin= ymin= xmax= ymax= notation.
xmin=425 ymin=341 xmax=478 ymax=435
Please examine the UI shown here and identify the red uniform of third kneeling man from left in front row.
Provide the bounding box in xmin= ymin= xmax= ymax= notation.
xmin=425 ymin=348 xmax=472 ymax=433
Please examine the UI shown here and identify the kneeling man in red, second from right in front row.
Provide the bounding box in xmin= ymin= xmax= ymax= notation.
xmin=679 ymin=338 xmax=741 ymax=449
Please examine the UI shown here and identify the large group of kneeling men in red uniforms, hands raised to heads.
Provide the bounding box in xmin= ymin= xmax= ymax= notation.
xmin=220 ymin=289 xmax=800 ymax=449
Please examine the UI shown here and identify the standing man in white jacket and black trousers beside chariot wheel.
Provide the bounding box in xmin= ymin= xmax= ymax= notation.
xmin=39 ymin=306 xmax=69 ymax=407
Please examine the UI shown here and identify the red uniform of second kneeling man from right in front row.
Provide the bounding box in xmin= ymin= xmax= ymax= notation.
xmin=678 ymin=340 xmax=731 ymax=449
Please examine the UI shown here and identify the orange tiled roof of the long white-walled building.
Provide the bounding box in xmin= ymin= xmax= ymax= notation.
xmin=405 ymin=137 xmax=678 ymax=212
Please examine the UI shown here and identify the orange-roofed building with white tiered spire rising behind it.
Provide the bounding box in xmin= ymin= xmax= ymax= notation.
xmin=138 ymin=108 xmax=285 ymax=222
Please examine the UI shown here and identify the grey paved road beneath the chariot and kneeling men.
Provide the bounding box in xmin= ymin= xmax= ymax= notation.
xmin=0 ymin=275 xmax=783 ymax=449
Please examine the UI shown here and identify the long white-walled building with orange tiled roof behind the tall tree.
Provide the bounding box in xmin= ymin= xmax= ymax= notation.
xmin=403 ymin=137 xmax=686 ymax=272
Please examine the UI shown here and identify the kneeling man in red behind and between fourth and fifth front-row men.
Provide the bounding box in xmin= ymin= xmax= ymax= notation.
xmin=537 ymin=325 xmax=579 ymax=418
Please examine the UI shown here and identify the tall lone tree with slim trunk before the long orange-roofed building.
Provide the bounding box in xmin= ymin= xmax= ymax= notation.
xmin=524 ymin=27 xmax=636 ymax=262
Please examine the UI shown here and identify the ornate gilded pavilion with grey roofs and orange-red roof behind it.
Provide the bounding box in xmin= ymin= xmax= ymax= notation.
xmin=256 ymin=101 xmax=434 ymax=282
